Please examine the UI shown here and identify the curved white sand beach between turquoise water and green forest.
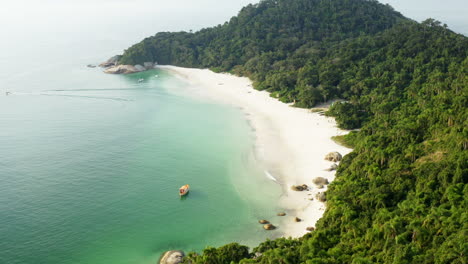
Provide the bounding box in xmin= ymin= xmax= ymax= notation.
xmin=158 ymin=66 xmax=351 ymax=237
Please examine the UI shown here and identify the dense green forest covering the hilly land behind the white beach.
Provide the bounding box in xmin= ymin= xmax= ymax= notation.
xmin=120 ymin=0 xmax=468 ymax=264
